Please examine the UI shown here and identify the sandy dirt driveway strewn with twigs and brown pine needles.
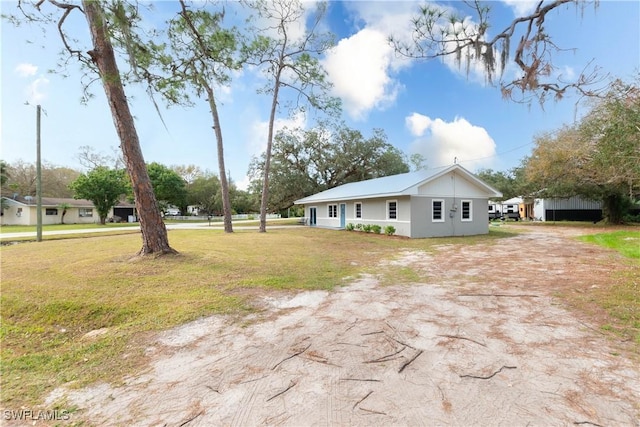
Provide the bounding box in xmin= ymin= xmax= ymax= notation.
xmin=50 ymin=227 xmax=640 ymax=426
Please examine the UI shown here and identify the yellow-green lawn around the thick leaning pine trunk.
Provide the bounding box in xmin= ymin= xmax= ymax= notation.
xmin=0 ymin=228 xmax=511 ymax=408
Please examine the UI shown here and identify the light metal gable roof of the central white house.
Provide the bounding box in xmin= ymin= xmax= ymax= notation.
xmin=294 ymin=164 xmax=502 ymax=205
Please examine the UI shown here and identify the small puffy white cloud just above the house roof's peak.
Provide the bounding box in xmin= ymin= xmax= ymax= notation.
xmin=405 ymin=113 xmax=496 ymax=170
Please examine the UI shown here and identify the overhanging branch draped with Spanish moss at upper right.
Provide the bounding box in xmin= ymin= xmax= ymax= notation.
xmin=389 ymin=0 xmax=604 ymax=104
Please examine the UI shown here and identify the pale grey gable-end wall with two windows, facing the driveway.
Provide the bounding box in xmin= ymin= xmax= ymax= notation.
xmin=410 ymin=196 xmax=489 ymax=238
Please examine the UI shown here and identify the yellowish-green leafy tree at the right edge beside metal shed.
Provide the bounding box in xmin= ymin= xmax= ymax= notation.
xmin=524 ymin=80 xmax=640 ymax=223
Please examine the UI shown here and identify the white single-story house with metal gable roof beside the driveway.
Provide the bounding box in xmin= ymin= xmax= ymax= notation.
xmin=294 ymin=164 xmax=502 ymax=238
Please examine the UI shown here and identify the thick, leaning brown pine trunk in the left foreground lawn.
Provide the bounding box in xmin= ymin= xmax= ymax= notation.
xmin=82 ymin=0 xmax=177 ymax=255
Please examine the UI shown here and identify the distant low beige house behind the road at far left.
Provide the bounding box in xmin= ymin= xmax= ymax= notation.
xmin=0 ymin=196 xmax=135 ymax=225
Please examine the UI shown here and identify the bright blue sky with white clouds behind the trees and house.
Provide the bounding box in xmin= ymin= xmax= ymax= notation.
xmin=0 ymin=0 xmax=640 ymax=188
